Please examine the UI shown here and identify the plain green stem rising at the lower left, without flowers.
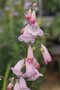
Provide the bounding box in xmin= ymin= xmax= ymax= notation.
xmin=2 ymin=63 xmax=11 ymax=90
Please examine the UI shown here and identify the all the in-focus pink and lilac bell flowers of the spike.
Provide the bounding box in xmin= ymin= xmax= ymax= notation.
xmin=7 ymin=4 xmax=52 ymax=90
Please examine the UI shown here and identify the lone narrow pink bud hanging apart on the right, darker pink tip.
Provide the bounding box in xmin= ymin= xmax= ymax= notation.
xmin=41 ymin=44 xmax=52 ymax=64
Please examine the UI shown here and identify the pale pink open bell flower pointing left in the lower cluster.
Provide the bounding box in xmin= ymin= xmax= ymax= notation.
xmin=11 ymin=59 xmax=24 ymax=76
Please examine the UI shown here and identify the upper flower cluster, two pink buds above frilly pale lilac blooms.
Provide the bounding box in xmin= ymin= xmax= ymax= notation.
xmin=18 ymin=9 xmax=44 ymax=43
